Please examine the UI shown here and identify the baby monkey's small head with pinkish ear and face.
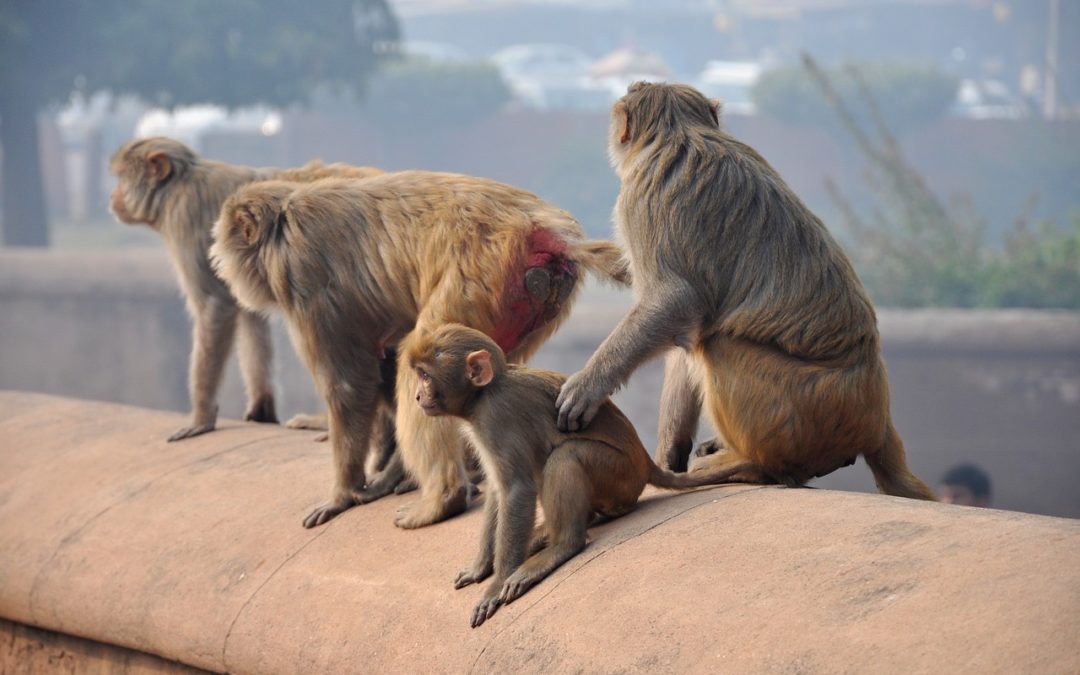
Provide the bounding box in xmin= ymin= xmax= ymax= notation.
xmin=407 ymin=323 xmax=507 ymax=418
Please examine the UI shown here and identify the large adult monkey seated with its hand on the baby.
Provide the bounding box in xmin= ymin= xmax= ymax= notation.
xmin=557 ymin=82 xmax=934 ymax=499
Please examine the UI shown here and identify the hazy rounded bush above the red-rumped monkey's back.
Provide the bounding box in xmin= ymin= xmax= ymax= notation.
xmin=364 ymin=58 xmax=511 ymax=133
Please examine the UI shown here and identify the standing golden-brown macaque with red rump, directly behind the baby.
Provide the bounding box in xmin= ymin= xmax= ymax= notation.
xmin=212 ymin=171 xmax=629 ymax=528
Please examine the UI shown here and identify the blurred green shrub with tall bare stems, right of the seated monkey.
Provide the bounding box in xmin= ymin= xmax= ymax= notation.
xmin=805 ymin=58 xmax=1080 ymax=309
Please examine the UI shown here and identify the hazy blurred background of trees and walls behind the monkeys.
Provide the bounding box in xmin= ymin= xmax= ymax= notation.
xmin=0 ymin=0 xmax=1080 ymax=517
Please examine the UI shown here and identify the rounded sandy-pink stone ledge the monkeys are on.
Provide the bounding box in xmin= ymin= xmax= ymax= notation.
xmin=0 ymin=392 xmax=1080 ymax=673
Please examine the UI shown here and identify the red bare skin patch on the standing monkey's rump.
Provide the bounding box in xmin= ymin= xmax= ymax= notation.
xmin=491 ymin=228 xmax=578 ymax=353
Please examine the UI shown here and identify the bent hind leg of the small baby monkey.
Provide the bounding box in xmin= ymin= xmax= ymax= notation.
xmin=499 ymin=444 xmax=591 ymax=604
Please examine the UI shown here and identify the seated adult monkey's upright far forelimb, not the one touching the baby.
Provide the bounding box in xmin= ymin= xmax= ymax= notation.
xmin=657 ymin=349 xmax=701 ymax=472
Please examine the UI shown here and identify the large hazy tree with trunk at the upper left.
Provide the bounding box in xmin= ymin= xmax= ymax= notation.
xmin=0 ymin=0 xmax=399 ymax=246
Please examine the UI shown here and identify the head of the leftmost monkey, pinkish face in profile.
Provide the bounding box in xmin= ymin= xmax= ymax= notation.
xmin=109 ymin=136 xmax=199 ymax=227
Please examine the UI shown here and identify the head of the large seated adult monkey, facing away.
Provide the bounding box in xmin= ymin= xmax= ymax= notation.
xmin=608 ymin=82 xmax=720 ymax=168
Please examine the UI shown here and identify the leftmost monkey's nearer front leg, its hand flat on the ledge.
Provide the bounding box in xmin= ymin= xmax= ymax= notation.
xmin=168 ymin=296 xmax=237 ymax=442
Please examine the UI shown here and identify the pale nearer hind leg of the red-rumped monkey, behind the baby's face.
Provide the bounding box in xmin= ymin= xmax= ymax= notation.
xmin=394 ymin=347 xmax=469 ymax=529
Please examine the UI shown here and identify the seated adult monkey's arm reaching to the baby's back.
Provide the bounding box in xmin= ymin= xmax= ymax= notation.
xmin=555 ymin=282 xmax=699 ymax=431
